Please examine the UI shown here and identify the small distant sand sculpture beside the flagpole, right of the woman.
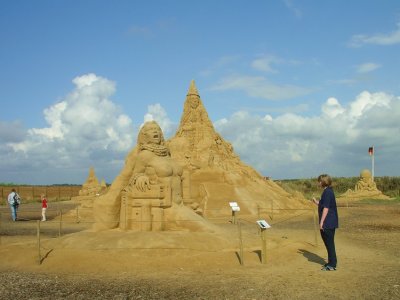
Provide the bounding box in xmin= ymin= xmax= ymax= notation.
xmin=339 ymin=169 xmax=390 ymax=200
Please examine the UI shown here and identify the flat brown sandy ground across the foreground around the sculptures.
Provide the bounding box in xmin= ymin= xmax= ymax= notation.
xmin=0 ymin=203 xmax=400 ymax=299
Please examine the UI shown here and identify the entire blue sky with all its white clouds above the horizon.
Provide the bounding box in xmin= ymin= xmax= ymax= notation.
xmin=0 ymin=0 xmax=400 ymax=184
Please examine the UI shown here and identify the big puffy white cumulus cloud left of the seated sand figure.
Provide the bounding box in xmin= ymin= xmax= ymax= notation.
xmin=0 ymin=74 xmax=137 ymax=183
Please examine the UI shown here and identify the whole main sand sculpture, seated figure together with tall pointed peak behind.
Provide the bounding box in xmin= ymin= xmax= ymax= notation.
xmin=94 ymin=81 xmax=305 ymax=231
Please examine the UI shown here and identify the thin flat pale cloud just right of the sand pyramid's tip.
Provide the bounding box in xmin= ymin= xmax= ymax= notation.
xmin=211 ymin=75 xmax=312 ymax=100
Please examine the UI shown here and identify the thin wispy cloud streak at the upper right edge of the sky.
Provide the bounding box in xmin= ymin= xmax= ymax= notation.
xmin=349 ymin=22 xmax=400 ymax=47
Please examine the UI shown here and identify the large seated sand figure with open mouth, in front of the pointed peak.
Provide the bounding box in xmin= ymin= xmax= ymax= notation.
xmin=94 ymin=121 xmax=212 ymax=231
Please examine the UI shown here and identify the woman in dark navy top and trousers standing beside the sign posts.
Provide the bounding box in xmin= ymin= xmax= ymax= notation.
xmin=312 ymin=174 xmax=339 ymax=271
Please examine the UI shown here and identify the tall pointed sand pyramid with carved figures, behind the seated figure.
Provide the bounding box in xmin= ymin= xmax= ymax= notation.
xmin=167 ymin=81 xmax=305 ymax=217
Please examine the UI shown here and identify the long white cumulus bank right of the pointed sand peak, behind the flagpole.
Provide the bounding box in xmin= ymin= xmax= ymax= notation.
xmin=215 ymin=91 xmax=400 ymax=178
